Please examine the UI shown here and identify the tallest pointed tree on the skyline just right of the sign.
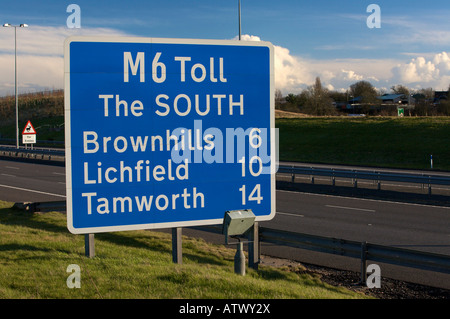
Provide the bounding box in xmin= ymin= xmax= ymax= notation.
xmin=304 ymin=77 xmax=336 ymax=116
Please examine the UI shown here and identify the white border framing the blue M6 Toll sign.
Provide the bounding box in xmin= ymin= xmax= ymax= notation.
xmin=64 ymin=36 xmax=278 ymax=234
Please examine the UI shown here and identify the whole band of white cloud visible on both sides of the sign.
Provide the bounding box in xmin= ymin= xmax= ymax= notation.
xmin=0 ymin=30 xmax=450 ymax=95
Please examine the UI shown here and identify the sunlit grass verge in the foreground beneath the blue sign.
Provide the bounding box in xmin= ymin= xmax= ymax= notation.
xmin=0 ymin=201 xmax=366 ymax=299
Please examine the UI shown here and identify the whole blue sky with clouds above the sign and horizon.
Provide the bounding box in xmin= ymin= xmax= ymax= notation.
xmin=0 ymin=0 xmax=450 ymax=96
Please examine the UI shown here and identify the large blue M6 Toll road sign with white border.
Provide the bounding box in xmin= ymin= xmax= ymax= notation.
xmin=64 ymin=37 xmax=276 ymax=234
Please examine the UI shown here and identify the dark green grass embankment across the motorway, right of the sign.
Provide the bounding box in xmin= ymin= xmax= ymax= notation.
xmin=276 ymin=117 xmax=450 ymax=171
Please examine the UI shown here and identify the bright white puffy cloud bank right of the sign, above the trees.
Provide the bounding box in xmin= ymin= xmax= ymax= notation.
xmin=242 ymin=35 xmax=450 ymax=94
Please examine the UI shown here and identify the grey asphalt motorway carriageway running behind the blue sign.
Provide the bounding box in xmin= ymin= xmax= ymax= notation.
xmin=0 ymin=160 xmax=450 ymax=289
